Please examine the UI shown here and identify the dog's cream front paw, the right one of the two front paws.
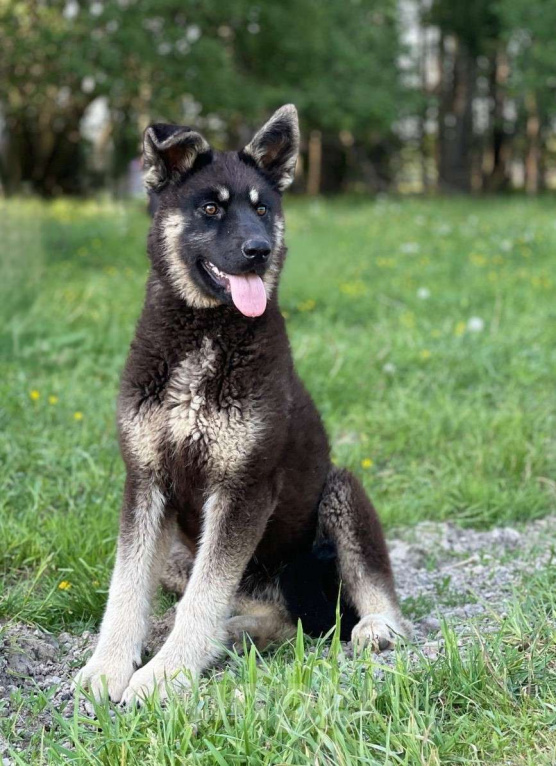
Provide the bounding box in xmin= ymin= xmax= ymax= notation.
xmin=121 ymin=649 xmax=191 ymax=705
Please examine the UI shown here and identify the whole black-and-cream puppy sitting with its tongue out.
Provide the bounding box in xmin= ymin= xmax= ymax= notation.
xmin=77 ymin=105 xmax=410 ymax=702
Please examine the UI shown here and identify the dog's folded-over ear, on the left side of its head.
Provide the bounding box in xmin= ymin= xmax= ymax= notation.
xmin=143 ymin=122 xmax=210 ymax=192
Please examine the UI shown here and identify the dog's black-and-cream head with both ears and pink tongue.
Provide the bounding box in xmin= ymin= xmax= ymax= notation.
xmin=143 ymin=105 xmax=299 ymax=317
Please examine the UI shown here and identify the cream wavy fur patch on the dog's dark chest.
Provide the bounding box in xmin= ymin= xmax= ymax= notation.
xmin=122 ymin=338 xmax=264 ymax=479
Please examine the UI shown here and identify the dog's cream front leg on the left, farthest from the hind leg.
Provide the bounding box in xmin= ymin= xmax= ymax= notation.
xmin=75 ymin=477 xmax=169 ymax=702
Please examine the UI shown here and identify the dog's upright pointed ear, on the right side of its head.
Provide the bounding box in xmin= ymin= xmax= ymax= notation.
xmin=240 ymin=104 xmax=299 ymax=191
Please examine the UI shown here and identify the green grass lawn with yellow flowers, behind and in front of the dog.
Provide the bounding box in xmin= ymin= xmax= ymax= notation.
xmin=0 ymin=198 xmax=556 ymax=766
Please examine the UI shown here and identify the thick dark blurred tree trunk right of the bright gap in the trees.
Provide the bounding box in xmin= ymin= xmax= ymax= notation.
xmin=438 ymin=37 xmax=475 ymax=193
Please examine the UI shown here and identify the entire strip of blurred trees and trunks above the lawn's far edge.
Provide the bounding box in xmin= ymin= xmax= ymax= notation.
xmin=0 ymin=0 xmax=556 ymax=196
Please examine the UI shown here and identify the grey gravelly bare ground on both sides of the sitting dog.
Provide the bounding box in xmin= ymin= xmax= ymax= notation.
xmin=0 ymin=516 xmax=556 ymax=766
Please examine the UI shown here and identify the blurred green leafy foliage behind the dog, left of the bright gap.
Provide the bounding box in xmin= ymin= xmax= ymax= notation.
xmin=0 ymin=0 xmax=408 ymax=195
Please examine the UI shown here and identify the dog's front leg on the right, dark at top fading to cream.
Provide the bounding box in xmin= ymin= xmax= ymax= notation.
xmin=122 ymin=483 xmax=276 ymax=702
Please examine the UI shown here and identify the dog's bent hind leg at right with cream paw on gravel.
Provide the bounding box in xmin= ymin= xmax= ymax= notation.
xmin=319 ymin=468 xmax=411 ymax=651
